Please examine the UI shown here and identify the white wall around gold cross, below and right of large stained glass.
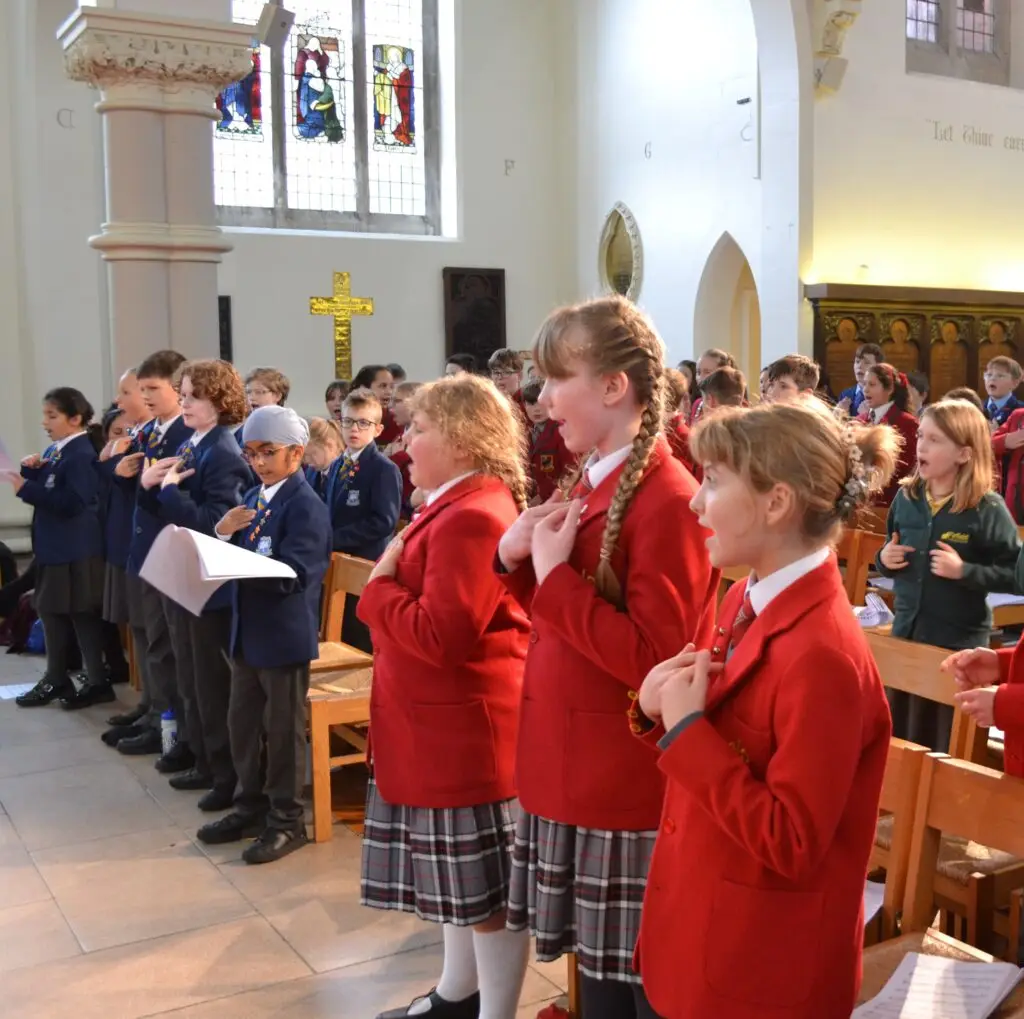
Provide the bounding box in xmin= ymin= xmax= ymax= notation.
xmin=220 ymin=0 xmax=575 ymax=413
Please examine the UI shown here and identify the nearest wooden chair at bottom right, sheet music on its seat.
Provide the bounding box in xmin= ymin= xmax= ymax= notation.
xmin=860 ymin=754 xmax=1024 ymax=1007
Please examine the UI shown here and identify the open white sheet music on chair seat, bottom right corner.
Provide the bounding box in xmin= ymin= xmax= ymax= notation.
xmin=853 ymin=951 xmax=1024 ymax=1019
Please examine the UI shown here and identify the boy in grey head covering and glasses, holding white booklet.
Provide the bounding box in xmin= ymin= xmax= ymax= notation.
xmin=199 ymin=407 xmax=331 ymax=863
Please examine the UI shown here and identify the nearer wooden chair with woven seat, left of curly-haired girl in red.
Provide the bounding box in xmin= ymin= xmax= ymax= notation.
xmin=307 ymin=669 xmax=373 ymax=842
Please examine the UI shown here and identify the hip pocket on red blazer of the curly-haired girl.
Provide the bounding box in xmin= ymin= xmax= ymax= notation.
xmin=411 ymin=700 xmax=498 ymax=793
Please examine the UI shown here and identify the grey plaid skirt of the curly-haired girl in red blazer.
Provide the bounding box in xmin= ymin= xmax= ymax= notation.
xmin=360 ymin=778 xmax=517 ymax=927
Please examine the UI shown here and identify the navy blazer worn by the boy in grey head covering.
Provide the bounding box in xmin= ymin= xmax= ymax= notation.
xmin=230 ymin=471 xmax=331 ymax=669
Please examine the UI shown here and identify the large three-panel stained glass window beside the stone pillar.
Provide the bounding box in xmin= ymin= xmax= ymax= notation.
xmin=215 ymin=0 xmax=440 ymax=233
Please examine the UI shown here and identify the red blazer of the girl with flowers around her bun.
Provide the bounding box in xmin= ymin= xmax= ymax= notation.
xmin=636 ymin=557 xmax=891 ymax=1019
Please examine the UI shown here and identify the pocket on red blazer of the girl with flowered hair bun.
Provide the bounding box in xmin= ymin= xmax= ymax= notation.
xmin=705 ymin=880 xmax=825 ymax=1009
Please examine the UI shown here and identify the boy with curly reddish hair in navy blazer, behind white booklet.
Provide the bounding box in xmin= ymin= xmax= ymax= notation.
xmin=139 ymin=360 xmax=251 ymax=810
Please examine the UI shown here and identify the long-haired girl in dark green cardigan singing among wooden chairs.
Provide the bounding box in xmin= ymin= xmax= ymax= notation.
xmin=876 ymin=399 xmax=1020 ymax=753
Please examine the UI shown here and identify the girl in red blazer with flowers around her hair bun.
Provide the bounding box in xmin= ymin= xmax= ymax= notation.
xmin=637 ymin=397 xmax=896 ymax=1019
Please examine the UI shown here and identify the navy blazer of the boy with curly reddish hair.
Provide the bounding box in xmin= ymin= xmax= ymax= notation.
xmin=138 ymin=425 xmax=250 ymax=611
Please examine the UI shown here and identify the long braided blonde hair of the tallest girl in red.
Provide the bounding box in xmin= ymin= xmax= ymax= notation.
xmin=534 ymin=295 xmax=665 ymax=606
